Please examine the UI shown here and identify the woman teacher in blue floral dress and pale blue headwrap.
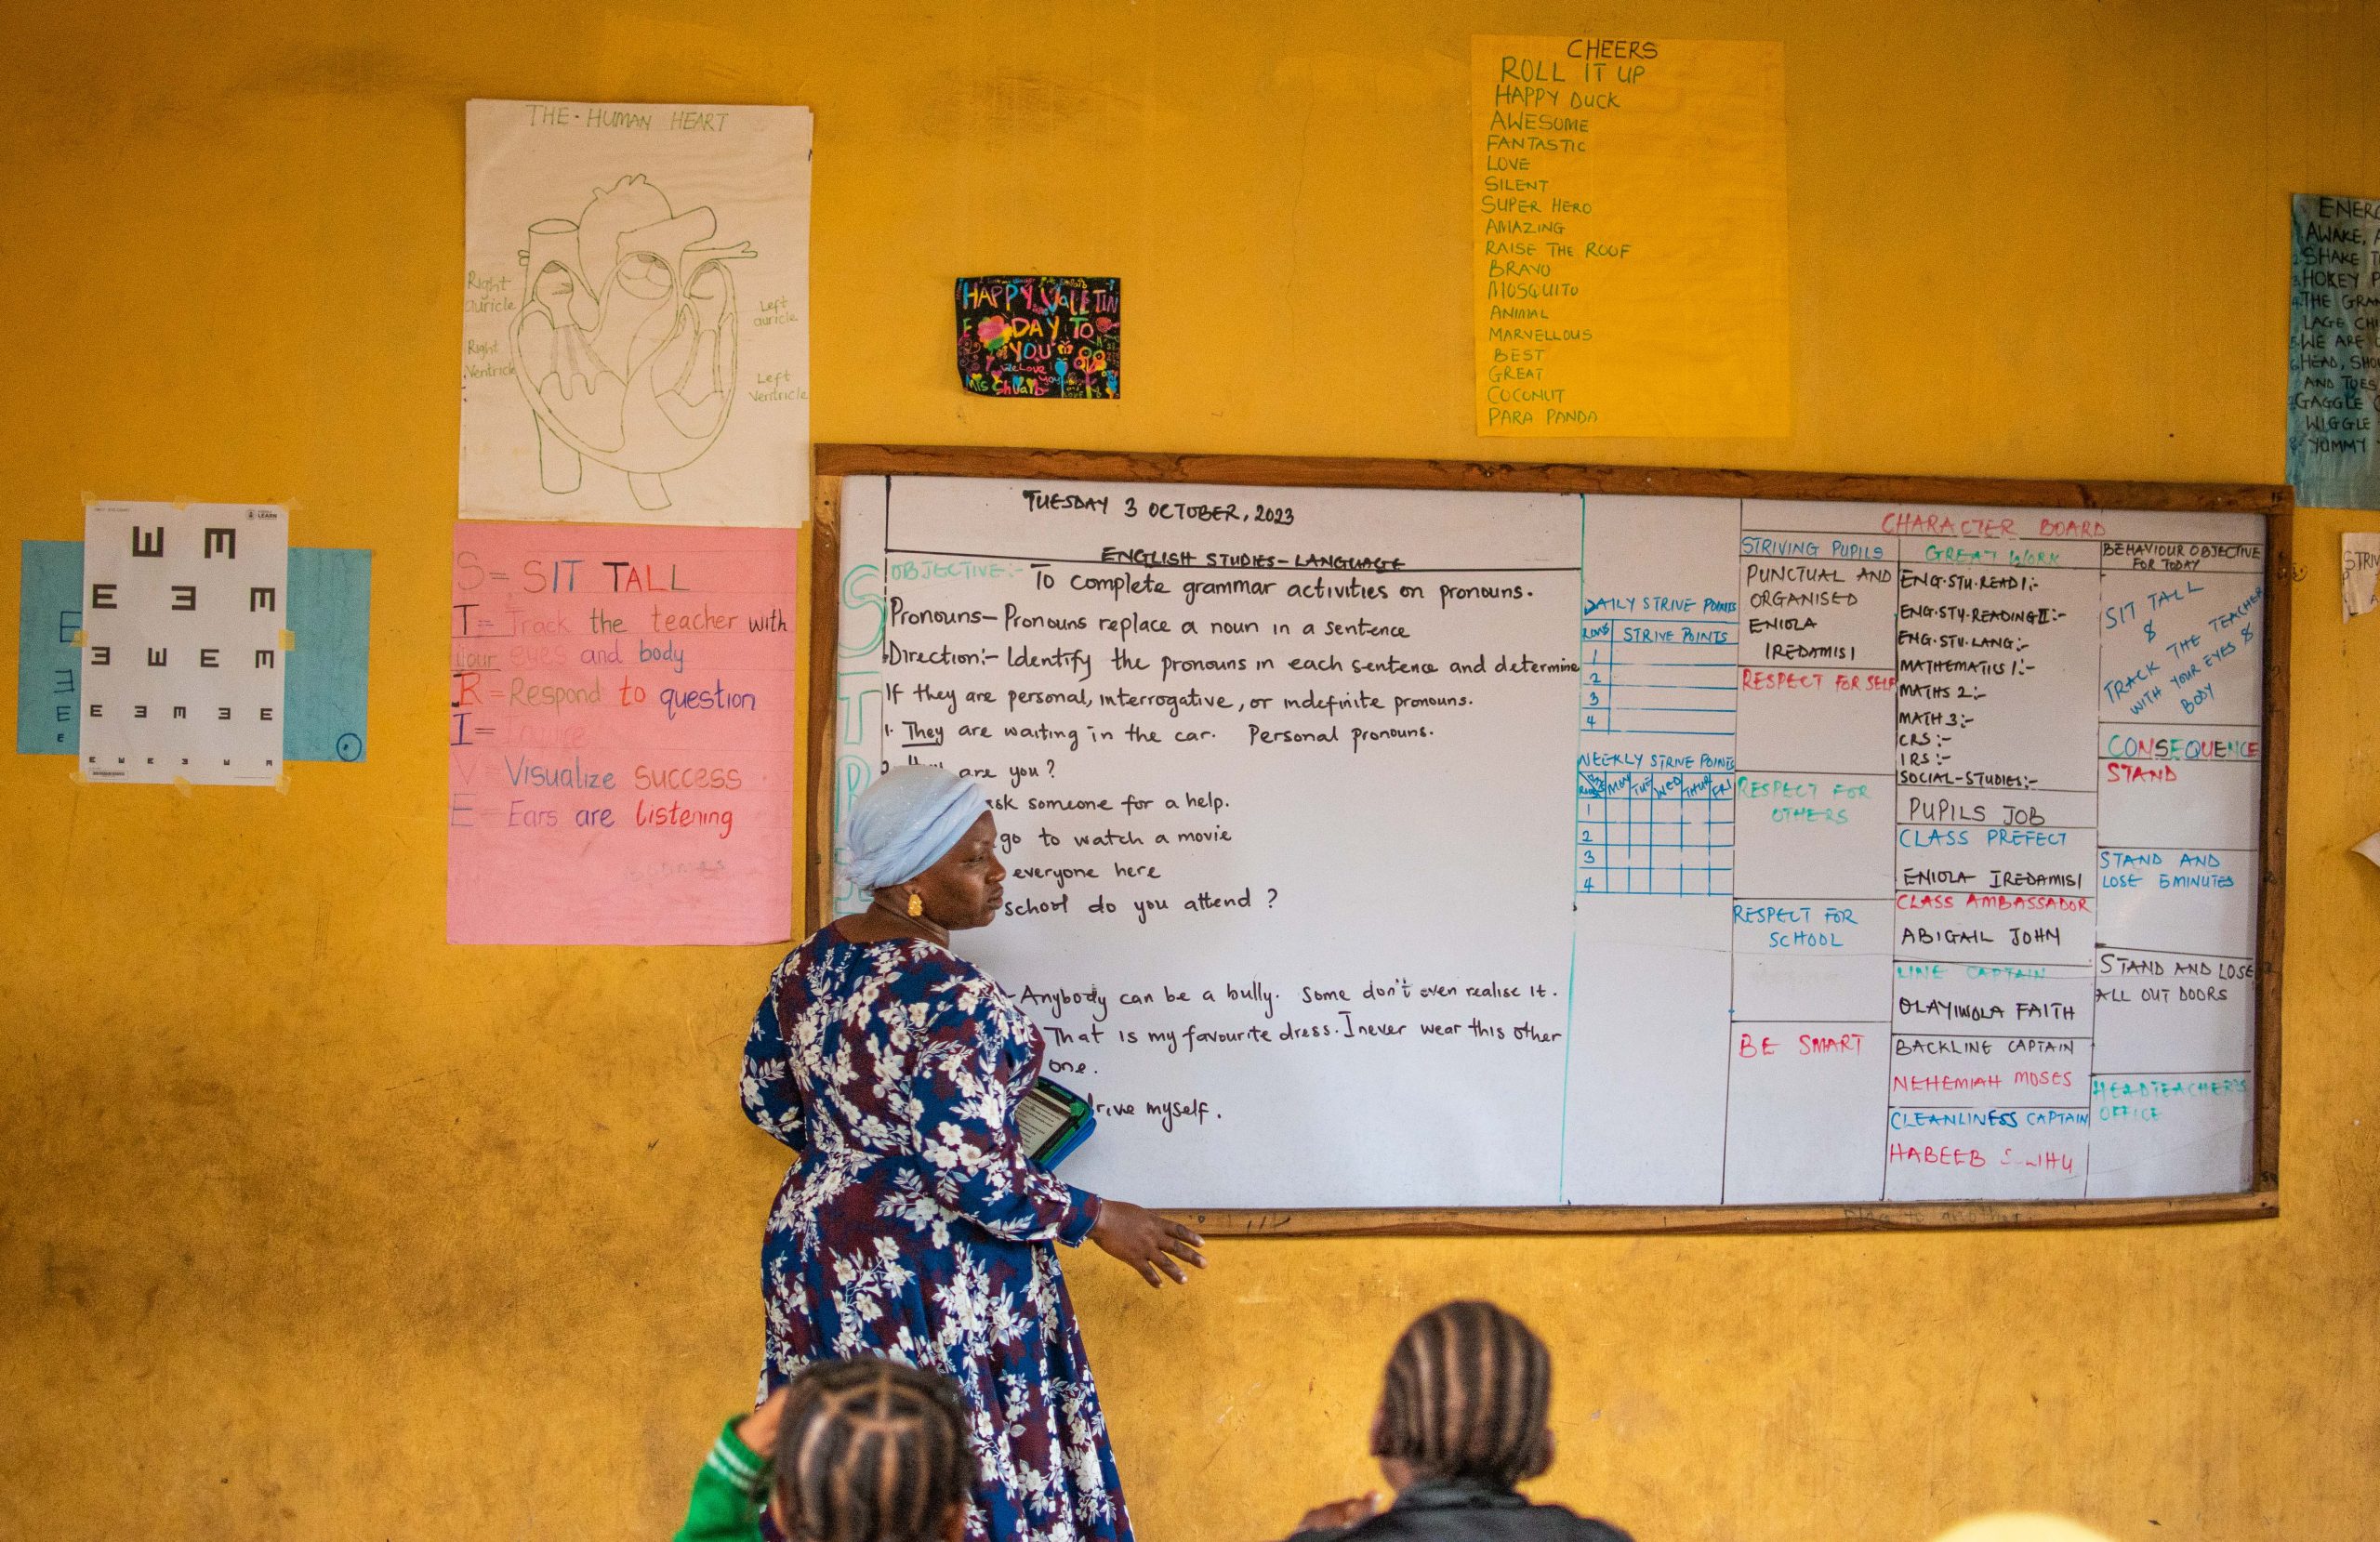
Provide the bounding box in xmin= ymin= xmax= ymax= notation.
xmin=743 ymin=766 xmax=1207 ymax=1542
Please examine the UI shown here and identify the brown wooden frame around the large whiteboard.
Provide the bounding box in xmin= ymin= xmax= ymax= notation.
xmin=802 ymin=445 xmax=2296 ymax=1237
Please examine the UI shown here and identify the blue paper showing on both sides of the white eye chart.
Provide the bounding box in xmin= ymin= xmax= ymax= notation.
xmin=17 ymin=540 xmax=371 ymax=761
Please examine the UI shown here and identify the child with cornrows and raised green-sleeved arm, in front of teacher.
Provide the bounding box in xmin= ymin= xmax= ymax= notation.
xmin=673 ymin=1356 xmax=976 ymax=1542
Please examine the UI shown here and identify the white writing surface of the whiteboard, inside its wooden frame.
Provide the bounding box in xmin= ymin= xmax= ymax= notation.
xmin=830 ymin=464 xmax=2266 ymax=1211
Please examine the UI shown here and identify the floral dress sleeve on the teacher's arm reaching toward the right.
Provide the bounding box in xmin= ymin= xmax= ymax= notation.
xmin=909 ymin=985 xmax=1100 ymax=1247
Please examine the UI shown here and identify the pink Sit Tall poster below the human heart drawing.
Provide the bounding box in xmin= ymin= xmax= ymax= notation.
xmin=447 ymin=523 xmax=798 ymax=944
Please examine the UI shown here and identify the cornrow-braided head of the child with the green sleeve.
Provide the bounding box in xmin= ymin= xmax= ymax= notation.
xmin=776 ymin=1359 xmax=976 ymax=1542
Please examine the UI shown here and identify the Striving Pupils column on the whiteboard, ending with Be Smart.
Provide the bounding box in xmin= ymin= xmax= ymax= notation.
xmin=1726 ymin=502 xmax=1899 ymax=1204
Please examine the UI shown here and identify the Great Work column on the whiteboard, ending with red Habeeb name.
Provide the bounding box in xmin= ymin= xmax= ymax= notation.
xmin=1885 ymin=523 xmax=2099 ymax=1199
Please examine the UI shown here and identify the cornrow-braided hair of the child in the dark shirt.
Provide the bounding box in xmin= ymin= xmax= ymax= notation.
xmin=1371 ymin=1301 xmax=1554 ymax=1487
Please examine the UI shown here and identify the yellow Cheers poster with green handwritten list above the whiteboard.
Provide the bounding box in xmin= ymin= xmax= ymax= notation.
xmin=1471 ymin=35 xmax=1792 ymax=438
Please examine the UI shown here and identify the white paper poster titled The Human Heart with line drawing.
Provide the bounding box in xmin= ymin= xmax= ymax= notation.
xmin=459 ymin=102 xmax=812 ymax=526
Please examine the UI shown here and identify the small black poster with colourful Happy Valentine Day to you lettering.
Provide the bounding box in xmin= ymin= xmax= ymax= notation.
xmin=957 ymin=273 xmax=1123 ymax=398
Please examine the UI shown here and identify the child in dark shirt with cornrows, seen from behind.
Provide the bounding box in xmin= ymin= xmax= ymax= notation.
xmin=1295 ymin=1301 xmax=1631 ymax=1542
